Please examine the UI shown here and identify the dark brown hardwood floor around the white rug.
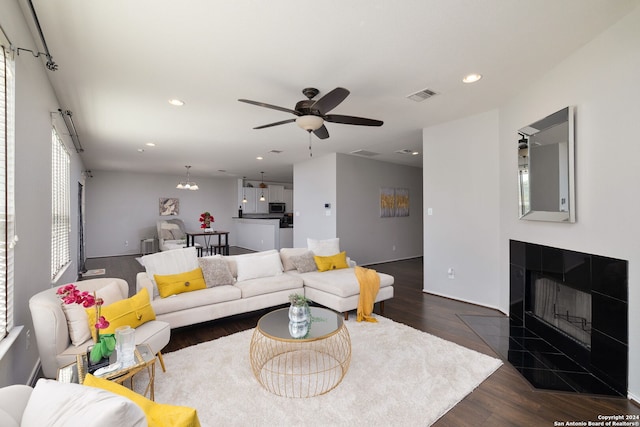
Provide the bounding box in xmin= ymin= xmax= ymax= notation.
xmin=87 ymin=248 xmax=640 ymax=427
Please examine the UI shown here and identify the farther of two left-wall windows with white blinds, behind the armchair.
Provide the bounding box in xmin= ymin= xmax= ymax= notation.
xmin=51 ymin=129 xmax=71 ymax=279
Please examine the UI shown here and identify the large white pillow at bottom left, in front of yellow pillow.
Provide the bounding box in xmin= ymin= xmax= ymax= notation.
xmin=20 ymin=378 xmax=147 ymax=427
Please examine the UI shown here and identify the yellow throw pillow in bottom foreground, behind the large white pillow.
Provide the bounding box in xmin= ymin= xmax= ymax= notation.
xmin=83 ymin=374 xmax=200 ymax=427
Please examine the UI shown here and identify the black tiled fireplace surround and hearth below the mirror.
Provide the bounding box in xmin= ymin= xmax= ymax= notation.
xmin=461 ymin=240 xmax=628 ymax=397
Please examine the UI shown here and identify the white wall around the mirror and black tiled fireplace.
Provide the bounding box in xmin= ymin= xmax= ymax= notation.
xmin=499 ymin=8 xmax=640 ymax=401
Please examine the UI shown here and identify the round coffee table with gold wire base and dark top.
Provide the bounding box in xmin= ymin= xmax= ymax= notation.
xmin=249 ymin=307 xmax=351 ymax=397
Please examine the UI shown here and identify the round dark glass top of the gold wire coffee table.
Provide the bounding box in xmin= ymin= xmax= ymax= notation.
xmin=258 ymin=307 xmax=342 ymax=341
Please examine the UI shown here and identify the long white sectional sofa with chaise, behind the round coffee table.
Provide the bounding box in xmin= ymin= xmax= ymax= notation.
xmin=136 ymin=247 xmax=394 ymax=328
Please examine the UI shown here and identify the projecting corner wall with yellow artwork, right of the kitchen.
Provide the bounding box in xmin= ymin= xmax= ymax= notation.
xmin=294 ymin=153 xmax=422 ymax=264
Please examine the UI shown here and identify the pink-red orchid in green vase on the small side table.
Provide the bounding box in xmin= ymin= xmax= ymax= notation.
xmin=56 ymin=283 xmax=116 ymax=363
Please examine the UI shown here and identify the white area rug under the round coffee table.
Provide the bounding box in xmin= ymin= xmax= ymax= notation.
xmin=145 ymin=316 xmax=502 ymax=426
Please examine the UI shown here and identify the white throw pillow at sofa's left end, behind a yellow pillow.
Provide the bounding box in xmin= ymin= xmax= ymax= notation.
xmin=140 ymin=246 xmax=200 ymax=299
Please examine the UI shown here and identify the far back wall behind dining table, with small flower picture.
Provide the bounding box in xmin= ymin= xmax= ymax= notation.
xmin=86 ymin=171 xmax=238 ymax=258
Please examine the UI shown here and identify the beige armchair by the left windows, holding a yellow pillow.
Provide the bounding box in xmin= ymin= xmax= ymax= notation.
xmin=29 ymin=278 xmax=171 ymax=378
